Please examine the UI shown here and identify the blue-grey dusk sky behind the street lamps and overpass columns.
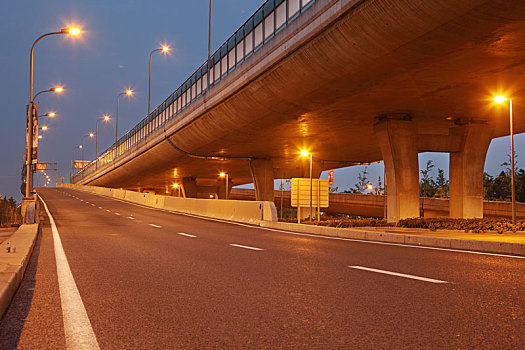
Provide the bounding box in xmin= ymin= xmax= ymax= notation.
xmin=0 ymin=0 xmax=525 ymax=200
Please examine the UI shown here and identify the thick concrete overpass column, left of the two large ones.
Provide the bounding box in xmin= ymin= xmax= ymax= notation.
xmin=374 ymin=119 xmax=419 ymax=222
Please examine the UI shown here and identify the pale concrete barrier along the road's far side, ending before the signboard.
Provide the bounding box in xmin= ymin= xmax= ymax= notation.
xmin=59 ymin=184 xmax=277 ymax=225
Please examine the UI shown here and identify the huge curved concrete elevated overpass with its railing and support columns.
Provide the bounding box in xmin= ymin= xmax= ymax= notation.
xmin=72 ymin=0 xmax=525 ymax=221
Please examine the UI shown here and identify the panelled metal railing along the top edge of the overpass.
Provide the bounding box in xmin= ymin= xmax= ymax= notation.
xmin=71 ymin=0 xmax=316 ymax=183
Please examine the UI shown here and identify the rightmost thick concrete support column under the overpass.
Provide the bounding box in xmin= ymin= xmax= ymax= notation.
xmin=449 ymin=123 xmax=492 ymax=219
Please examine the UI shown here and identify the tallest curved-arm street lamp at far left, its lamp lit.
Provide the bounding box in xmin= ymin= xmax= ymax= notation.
xmin=25 ymin=28 xmax=80 ymax=198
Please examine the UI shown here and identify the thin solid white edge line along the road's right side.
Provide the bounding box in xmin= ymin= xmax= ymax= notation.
xmin=73 ymin=190 xmax=525 ymax=259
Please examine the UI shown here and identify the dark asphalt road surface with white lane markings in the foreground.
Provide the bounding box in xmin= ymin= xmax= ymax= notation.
xmin=0 ymin=189 xmax=525 ymax=349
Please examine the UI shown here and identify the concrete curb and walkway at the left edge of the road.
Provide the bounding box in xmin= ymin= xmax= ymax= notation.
xmin=0 ymin=224 xmax=39 ymax=318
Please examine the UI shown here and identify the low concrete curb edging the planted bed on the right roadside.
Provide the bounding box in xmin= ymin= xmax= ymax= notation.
xmin=260 ymin=221 xmax=525 ymax=256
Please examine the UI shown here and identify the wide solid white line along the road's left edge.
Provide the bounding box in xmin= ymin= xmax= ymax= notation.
xmin=40 ymin=197 xmax=100 ymax=349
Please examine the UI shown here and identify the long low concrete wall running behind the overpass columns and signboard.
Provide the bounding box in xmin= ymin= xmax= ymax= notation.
xmin=230 ymin=188 xmax=525 ymax=218
